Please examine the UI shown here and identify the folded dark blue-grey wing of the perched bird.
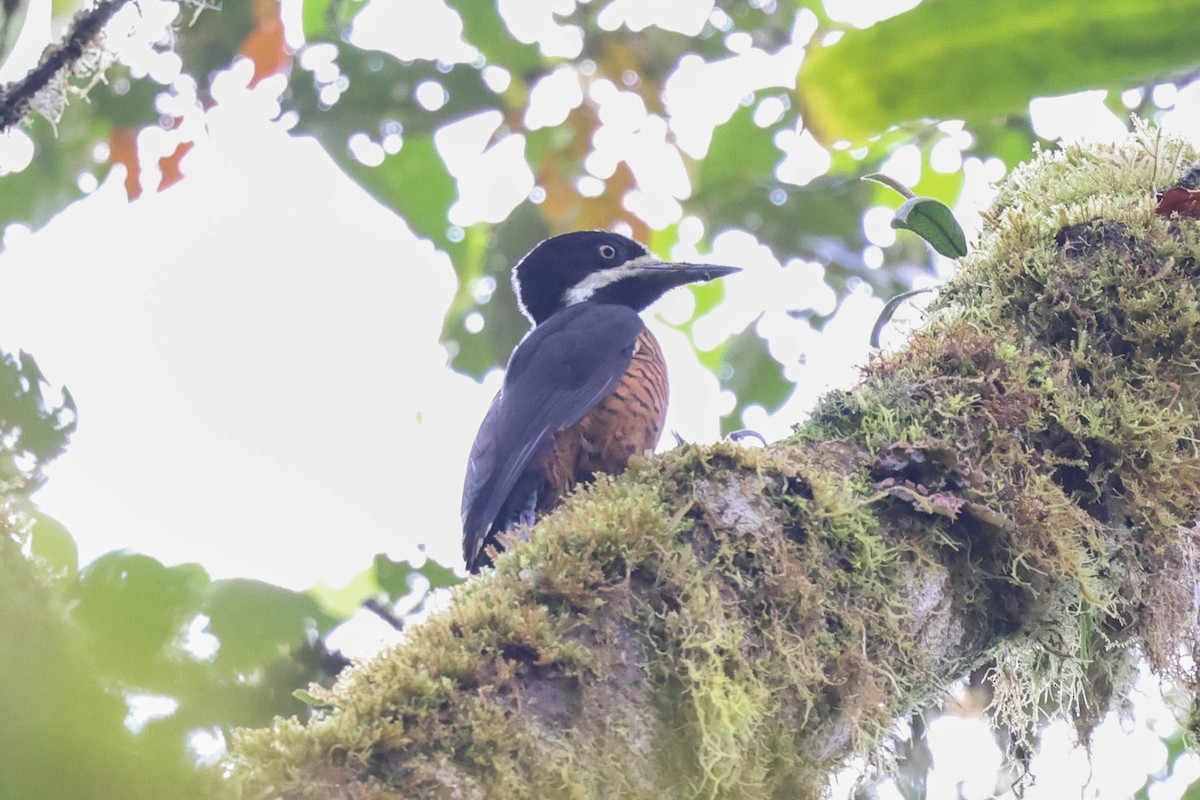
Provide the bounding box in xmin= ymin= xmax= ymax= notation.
xmin=462 ymin=302 xmax=643 ymax=569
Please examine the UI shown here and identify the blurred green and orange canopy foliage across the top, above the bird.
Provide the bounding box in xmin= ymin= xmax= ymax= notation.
xmin=0 ymin=0 xmax=1198 ymax=429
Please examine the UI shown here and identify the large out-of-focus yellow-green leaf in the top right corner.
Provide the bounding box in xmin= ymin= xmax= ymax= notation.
xmin=797 ymin=0 xmax=1200 ymax=142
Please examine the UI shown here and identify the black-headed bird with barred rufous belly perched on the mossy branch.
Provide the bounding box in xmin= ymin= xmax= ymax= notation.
xmin=462 ymin=230 xmax=740 ymax=572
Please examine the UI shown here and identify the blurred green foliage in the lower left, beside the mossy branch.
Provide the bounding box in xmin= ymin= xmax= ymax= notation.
xmin=0 ymin=351 xmax=460 ymax=800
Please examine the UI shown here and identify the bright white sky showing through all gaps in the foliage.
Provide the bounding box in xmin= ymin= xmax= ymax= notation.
xmin=0 ymin=0 xmax=1200 ymax=799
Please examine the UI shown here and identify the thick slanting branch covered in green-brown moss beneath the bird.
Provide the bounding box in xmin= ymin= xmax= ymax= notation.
xmin=225 ymin=131 xmax=1200 ymax=799
